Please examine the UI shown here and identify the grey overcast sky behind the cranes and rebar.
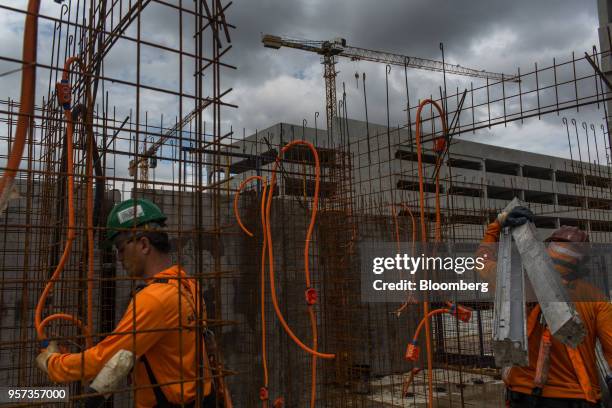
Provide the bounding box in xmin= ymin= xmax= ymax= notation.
xmin=0 ymin=0 xmax=604 ymax=169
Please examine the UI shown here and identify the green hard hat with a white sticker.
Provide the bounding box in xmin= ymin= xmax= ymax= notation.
xmin=105 ymin=198 xmax=168 ymax=245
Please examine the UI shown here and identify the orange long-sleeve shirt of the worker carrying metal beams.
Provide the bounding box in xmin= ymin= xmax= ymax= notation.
xmin=480 ymin=221 xmax=612 ymax=400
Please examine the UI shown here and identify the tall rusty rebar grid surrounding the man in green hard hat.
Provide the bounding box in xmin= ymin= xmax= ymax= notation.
xmin=0 ymin=0 xmax=239 ymax=406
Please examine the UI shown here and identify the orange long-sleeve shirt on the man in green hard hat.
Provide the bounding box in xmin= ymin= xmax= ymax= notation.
xmin=48 ymin=266 xmax=211 ymax=408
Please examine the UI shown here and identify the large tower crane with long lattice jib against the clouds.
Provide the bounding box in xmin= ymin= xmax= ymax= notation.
xmin=261 ymin=34 xmax=518 ymax=133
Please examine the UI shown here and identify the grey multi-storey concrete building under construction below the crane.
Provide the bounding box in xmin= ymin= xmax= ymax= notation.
xmin=226 ymin=119 xmax=612 ymax=242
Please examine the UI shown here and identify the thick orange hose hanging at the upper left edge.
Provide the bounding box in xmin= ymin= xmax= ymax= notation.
xmin=0 ymin=0 xmax=40 ymax=206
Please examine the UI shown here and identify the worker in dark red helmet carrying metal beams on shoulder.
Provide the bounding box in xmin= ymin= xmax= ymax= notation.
xmin=479 ymin=206 xmax=612 ymax=408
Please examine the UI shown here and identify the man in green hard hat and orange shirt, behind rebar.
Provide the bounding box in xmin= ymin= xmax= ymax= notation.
xmin=36 ymin=199 xmax=231 ymax=408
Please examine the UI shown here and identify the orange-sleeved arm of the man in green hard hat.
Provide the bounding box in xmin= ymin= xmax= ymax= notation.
xmin=47 ymin=291 xmax=166 ymax=383
